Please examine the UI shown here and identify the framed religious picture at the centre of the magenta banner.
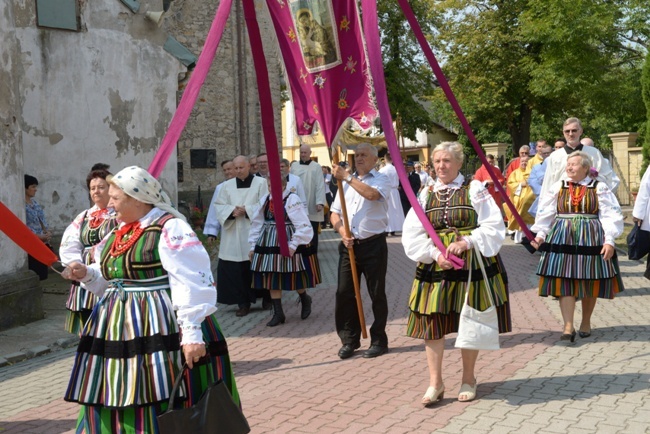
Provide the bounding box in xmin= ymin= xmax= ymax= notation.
xmin=290 ymin=0 xmax=341 ymax=73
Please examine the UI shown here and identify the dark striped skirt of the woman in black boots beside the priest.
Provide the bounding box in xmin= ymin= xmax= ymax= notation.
xmin=251 ymin=221 xmax=321 ymax=291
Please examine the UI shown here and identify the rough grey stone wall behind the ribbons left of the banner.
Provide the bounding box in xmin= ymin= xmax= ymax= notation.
xmin=170 ymin=0 xmax=281 ymax=195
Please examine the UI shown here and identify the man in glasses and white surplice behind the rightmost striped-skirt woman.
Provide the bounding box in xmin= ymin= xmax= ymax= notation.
xmin=539 ymin=118 xmax=617 ymax=198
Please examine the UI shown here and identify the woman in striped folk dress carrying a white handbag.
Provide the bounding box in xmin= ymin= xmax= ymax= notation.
xmin=402 ymin=142 xmax=511 ymax=406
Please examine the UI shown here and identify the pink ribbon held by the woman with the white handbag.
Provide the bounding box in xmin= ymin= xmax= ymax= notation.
xmin=362 ymin=0 xmax=464 ymax=269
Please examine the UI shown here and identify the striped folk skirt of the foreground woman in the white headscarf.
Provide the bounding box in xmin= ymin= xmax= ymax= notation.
xmin=64 ymin=290 xmax=239 ymax=434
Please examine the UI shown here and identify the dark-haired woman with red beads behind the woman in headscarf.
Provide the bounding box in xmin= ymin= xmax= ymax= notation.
xmin=59 ymin=169 xmax=117 ymax=334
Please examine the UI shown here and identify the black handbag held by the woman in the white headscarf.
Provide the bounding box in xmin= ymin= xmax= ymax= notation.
xmin=158 ymin=364 xmax=251 ymax=434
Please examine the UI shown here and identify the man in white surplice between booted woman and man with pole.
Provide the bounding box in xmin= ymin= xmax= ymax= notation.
xmin=291 ymin=145 xmax=327 ymax=252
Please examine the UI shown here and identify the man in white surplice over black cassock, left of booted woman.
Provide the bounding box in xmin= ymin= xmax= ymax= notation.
xmin=215 ymin=155 xmax=271 ymax=316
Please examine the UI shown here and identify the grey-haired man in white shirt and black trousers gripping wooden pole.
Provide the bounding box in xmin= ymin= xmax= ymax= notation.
xmin=330 ymin=143 xmax=391 ymax=359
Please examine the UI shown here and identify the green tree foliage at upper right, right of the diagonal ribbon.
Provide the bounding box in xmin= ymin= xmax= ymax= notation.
xmin=420 ymin=0 xmax=650 ymax=150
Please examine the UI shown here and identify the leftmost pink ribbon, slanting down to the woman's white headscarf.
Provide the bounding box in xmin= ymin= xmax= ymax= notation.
xmin=147 ymin=0 xmax=232 ymax=178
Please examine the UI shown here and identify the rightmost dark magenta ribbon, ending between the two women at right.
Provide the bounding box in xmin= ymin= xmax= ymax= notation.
xmin=394 ymin=0 xmax=535 ymax=241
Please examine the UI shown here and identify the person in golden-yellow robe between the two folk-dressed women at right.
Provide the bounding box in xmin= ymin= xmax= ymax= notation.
xmin=503 ymin=154 xmax=536 ymax=243
